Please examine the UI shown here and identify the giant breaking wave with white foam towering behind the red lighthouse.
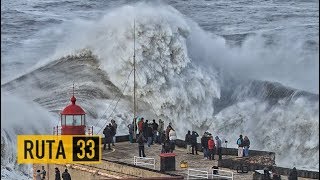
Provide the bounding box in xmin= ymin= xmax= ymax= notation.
xmin=1 ymin=3 xmax=319 ymax=179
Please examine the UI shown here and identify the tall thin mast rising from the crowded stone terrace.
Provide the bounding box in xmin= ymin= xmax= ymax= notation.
xmin=133 ymin=20 xmax=137 ymax=139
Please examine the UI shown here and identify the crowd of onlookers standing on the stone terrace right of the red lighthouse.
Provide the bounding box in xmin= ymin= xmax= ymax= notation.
xmin=103 ymin=117 xmax=250 ymax=160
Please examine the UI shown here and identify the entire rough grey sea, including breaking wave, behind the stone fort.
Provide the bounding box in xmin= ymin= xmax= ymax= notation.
xmin=1 ymin=0 xmax=319 ymax=179
